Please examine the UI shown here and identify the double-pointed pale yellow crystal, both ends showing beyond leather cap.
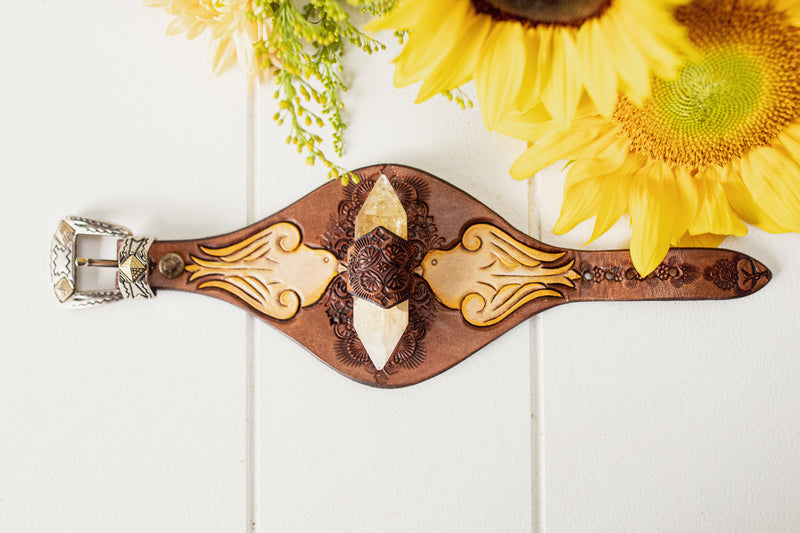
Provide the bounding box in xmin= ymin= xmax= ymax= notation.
xmin=353 ymin=174 xmax=408 ymax=370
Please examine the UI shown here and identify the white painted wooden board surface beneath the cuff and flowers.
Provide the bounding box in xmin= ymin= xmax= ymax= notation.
xmin=0 ymin=0 xmax=800 ymax=533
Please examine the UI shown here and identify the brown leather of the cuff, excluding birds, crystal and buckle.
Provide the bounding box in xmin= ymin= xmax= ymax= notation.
xmin=150 ymin=165 xmax=771 ymax=387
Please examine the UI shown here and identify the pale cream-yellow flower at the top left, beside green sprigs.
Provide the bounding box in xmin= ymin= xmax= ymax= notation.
xmin=144 ymin=0 xmax=280 ymax=84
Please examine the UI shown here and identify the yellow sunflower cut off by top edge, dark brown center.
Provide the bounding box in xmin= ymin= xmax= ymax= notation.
xmin=367 ymin=0 xmax=688 ymax=129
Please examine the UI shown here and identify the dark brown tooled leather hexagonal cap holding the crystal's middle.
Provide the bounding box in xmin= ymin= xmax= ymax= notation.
xmin=347 ymin=227 xmax=414 ymax=308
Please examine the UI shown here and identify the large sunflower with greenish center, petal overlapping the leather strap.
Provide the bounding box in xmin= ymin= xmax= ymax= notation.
xmin=500 ymin=0 xmax=800 ymax=274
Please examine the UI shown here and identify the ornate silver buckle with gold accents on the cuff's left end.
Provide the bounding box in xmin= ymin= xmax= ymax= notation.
xmin=50 ymin=217 xmax=155 ymax=309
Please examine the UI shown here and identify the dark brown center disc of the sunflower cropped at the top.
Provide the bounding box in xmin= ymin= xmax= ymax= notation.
xmin=472 ymin=0 xmax=611 ymax=25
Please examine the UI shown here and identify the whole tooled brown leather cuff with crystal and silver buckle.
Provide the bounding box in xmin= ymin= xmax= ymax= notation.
xmin=51 ymin=165 xmax=772 ymax=387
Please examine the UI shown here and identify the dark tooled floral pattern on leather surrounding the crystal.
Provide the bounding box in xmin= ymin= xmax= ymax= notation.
xmin=319 ymin=167 xmax=444 ymax=385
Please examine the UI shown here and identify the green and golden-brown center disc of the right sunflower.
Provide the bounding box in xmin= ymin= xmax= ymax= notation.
xmin=614 ymin=2 xmax=800 ymax=168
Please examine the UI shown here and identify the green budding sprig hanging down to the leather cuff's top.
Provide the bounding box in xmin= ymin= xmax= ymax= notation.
xmin=253 ymin=0 xmax=398 ymax=183
